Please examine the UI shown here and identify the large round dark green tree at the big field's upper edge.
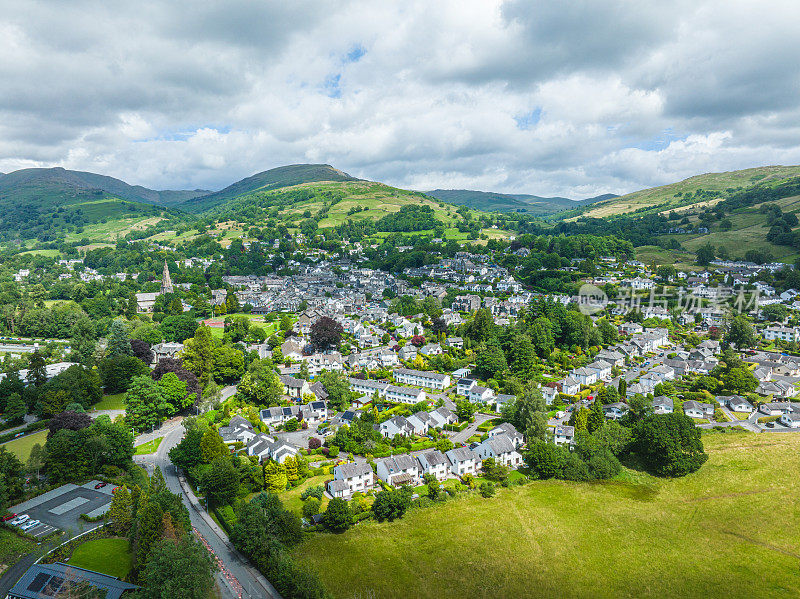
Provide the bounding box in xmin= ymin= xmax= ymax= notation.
xmin=633 ymin=412 xmax=708 ymax=476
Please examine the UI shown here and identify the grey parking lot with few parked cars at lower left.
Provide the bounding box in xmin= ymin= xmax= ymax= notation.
xmin=9 ymin=480 xmax=114 ymax=538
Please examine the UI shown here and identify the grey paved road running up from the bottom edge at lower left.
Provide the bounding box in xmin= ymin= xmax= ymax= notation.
xmin=139 ymin=422 xmax=281 ymax=599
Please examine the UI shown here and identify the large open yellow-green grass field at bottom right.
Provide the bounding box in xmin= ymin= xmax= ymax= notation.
xmin=294 ymin=433 xmax=800 ymax=599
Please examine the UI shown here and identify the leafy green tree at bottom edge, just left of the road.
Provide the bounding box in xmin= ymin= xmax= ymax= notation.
xmin=139 ymin=534 xmax=217 ymax=599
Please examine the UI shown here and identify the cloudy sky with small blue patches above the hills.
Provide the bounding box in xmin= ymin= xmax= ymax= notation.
xmin=0 ymin=0 xmax=800 ymax=198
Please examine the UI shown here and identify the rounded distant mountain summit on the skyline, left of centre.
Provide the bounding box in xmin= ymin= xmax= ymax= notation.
xmin=180 ymin=164 xmax=359 ymax=212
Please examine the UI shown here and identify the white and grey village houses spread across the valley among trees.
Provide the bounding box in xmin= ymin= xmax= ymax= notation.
xmin=28 ymin=248 xmax=800 ymax=498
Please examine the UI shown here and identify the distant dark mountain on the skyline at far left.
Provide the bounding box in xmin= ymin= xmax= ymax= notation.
xmin=0 ymin=167 xmax=208 ymax=206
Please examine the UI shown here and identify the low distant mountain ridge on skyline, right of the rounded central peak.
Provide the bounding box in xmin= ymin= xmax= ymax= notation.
xmin=425 ymin=189 xmax=617 ymax=216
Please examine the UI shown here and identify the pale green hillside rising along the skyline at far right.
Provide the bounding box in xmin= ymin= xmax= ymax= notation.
xmin=581 ymin=166 xmax=800 ymax=218
